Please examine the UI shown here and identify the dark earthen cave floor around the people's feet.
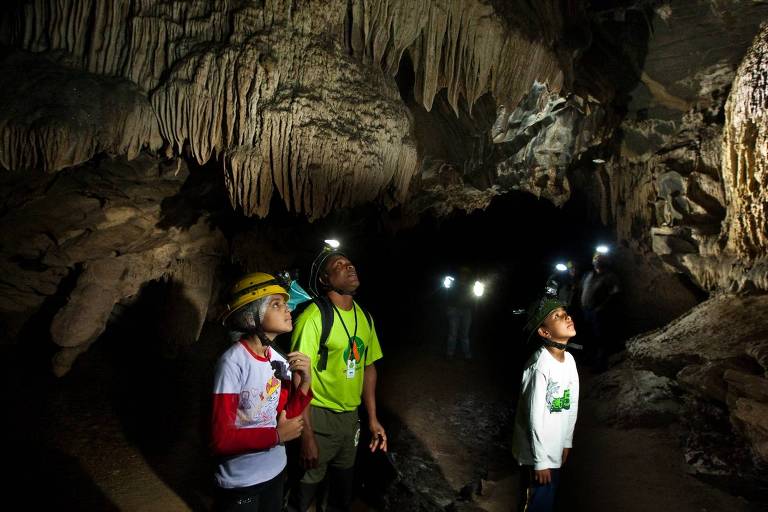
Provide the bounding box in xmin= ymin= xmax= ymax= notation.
xmin=0 ymin=327 xmax=761 ymax=512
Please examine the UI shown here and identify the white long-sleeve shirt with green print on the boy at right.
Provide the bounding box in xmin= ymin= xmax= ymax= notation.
xmin=512 ymin=347 xmax=579 ymax=469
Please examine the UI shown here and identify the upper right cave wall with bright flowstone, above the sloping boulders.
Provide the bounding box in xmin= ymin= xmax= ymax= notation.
xmin=592 ymin=1 xmax=768 ymax=292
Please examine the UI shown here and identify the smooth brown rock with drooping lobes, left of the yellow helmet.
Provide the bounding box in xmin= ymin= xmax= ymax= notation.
xmin=0 ymin=157 xmax=224 ymax=375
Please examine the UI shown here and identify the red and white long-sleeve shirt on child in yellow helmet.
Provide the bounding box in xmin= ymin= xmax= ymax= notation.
xmin=212 ymin=340 xmax=312 ymax=489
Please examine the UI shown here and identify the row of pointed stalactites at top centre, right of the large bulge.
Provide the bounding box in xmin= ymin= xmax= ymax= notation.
xmin=350 ymin=0 xmax=563 ymax=113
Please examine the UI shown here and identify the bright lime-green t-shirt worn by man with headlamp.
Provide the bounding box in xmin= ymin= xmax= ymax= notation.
xmin=291 ymin=303 xmax=382 ymax=412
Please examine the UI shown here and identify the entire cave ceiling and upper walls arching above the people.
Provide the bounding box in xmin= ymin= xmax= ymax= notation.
xmin=0 ymin=0 xmax=768 ymax=373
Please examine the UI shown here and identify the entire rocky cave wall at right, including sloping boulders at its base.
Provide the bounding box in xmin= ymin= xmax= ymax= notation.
xmin=572 ymin=1 xmax=768 ymax=478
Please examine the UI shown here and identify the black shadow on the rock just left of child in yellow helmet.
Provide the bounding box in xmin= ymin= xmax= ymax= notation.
xmin=92 ymin=281 xmax=223 ymax=511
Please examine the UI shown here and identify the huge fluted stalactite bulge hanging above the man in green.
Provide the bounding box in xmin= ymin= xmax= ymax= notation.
xmin=3 ymin=0 xmax=417 ymax=218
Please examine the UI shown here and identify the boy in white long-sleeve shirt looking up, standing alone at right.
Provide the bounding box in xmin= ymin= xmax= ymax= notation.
xmin=512 ymin=296 xmax=579 ymax=512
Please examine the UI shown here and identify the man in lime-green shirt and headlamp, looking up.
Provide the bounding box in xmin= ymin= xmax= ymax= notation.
xmin=288 ymin=250 xmax=387 ymax=512
